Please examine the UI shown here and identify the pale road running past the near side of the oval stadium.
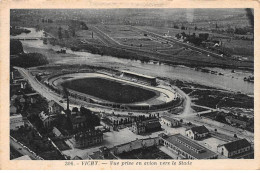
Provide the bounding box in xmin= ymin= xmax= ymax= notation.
xmin=15 ymin=67 xmax=254 ymax=141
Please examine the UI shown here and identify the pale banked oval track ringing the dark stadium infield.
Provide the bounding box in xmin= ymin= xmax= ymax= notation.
xmin=48 ymin=73 xmax=176 ymax=105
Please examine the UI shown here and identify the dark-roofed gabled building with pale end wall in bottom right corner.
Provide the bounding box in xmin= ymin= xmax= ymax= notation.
xmin=217 ymin=139 xmax=252 ymax=158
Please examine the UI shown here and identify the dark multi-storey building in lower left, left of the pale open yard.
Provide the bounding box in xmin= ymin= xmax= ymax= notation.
xmin=72 ymin=130 xmax=103 ymax=148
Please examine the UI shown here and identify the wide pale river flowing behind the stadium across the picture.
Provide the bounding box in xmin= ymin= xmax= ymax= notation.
xmin=11 ymin=28 xmax=254 ymax=95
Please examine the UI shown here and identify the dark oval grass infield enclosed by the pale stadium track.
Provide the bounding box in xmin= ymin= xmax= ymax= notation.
xmin=61 ymin=78 xmax=156 ymax=103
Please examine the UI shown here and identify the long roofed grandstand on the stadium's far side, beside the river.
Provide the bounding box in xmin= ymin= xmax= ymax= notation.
xmin=122 ymin=70 xmax=156 ymax=86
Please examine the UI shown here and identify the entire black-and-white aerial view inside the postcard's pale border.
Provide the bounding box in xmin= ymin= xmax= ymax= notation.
xmin=8 ymin=8 xmax=255 ymax=161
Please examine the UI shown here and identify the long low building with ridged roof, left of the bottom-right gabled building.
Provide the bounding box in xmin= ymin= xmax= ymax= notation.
xmin=159 ymin=133 xmax=218 ymax=160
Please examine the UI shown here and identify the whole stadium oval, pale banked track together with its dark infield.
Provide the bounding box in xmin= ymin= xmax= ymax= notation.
xmin=49 ymin=73 xmax=176 ymax=106
